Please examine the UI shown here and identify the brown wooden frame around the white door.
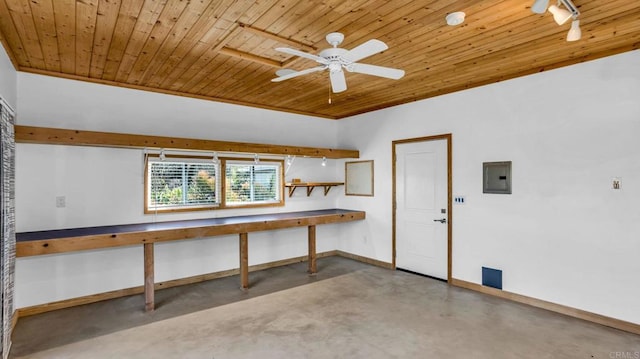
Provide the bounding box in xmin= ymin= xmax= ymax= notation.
xmin=391 ymin=133 xmax=453 ymax=283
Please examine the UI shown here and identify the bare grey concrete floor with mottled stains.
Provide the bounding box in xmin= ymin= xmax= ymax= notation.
xmin=11 ymin=257 xmax=640 ymax=359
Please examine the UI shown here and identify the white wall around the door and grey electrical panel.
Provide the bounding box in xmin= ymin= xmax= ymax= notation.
xmin=337 ymin=51 xmax=640 ymax=323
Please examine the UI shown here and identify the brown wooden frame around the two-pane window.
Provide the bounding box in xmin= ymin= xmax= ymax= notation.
xmin=143 ymin=154 xmax=285 ymax=214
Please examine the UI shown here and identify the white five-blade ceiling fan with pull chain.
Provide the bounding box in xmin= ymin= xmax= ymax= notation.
xmin=271 ymin=32 xmax=404 ymax=93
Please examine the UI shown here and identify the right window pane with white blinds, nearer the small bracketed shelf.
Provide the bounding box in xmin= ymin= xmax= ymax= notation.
xmin=225 ymin=161 xmax=282 ymax=205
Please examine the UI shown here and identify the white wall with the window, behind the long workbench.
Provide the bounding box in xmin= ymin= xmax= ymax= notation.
xmin=16 ymin=73 xmax=342 ymax=308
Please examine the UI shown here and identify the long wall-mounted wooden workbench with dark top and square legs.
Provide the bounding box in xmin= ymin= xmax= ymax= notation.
xmin=16 ymin=209 xmax=365 ymax=311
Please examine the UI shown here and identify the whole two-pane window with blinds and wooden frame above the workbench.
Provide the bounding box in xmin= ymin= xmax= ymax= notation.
xmin=145 ymin=156 xmax=284 ymax=213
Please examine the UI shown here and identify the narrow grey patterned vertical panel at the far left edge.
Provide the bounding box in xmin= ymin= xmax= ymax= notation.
xmin=0 ymin=99 xmax=16 ymax=359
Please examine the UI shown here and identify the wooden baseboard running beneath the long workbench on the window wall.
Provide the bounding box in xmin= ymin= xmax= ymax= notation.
xmin=15 ymin=250 xmax=338 ymax=322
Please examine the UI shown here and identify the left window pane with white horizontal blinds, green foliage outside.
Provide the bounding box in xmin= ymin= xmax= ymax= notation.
xmin=147 ymin=159 xmax=220 ymax=210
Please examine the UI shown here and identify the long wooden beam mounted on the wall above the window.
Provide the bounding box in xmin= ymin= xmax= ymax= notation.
xmin=15 ymin=126 xmax=360 ymax=159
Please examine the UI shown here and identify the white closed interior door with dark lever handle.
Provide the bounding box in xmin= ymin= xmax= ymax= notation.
xmin=396 ymin=139 xmax=448 ymax=280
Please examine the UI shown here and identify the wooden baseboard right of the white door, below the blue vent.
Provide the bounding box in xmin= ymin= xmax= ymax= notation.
xmin=450 ymin=278 xmax=640 ymax=335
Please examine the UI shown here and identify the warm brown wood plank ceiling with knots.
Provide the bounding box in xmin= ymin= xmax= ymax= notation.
xmin=0 ymin=0 xmax=640 ymax=119
